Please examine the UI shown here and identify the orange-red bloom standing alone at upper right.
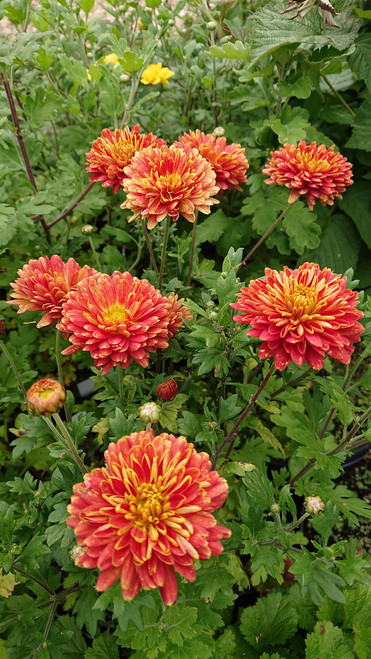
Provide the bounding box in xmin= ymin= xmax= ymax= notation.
xmin=263 ymin=141 xmax=353 ymax=210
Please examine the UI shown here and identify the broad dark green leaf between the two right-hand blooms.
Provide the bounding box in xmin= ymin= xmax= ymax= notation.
xmin=305 ymin=214 xmax=361 ymax=274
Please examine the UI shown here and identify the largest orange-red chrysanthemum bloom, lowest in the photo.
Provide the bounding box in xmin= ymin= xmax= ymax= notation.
xmin=67 ymin=430 xmax=230 ymax=605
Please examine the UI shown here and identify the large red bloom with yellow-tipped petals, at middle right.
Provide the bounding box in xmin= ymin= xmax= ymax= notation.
xmin=231 ymin=263 xmax=364 ymax=371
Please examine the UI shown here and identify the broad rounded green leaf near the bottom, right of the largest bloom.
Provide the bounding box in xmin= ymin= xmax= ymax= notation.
xmin=240 ymin=593 xmax=298 ymax=651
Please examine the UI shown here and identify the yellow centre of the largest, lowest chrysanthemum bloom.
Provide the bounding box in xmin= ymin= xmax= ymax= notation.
xmin=130 ymin=483 xmax=168 ymax=530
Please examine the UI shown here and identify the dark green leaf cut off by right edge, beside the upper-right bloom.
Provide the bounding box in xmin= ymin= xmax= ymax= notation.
xmin=339 ymin=181 xmax=371 ymax=248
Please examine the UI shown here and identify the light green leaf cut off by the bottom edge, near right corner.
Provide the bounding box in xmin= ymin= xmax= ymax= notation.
xmin=305 ymin=620 xmax=354 ymax=659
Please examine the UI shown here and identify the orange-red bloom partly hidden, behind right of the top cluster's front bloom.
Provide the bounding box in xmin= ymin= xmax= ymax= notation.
xmin=175 ymin=129 xmax=249 ymax=196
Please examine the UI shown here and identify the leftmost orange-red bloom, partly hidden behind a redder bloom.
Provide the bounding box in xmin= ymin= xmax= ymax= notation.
xmin=8 ymin=254 xmax=96 ymax=327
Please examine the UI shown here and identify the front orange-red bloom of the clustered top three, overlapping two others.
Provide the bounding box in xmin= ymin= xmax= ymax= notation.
xmin=121 ymin=146 xmax=219 ymax=229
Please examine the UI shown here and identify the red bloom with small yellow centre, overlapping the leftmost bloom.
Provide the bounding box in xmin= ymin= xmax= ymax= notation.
xmin=57 ymin=272 xmax=169 ymax=373
